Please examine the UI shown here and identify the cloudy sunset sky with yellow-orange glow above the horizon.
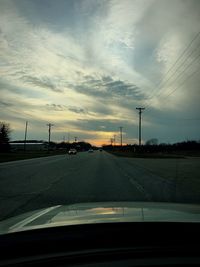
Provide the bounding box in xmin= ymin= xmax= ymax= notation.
xmin=0 ymin=0 xmax=200 ymax=145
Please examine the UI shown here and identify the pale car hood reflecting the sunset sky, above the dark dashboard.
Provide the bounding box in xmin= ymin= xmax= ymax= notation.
xmin=0 ymin=202 xmax=200 ymax=234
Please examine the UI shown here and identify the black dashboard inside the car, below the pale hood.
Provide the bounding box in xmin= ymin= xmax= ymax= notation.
xmin=0 ymin=222 xmax=200 ymax=266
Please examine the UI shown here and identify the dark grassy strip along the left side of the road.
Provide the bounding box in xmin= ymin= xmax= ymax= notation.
xmin=0 ymin=151 xmax=66 ymax=163
